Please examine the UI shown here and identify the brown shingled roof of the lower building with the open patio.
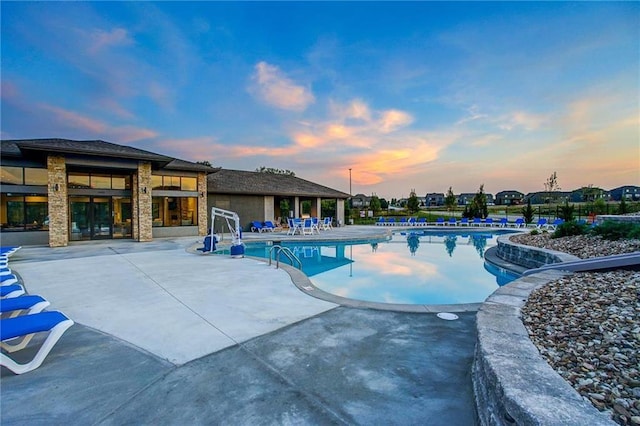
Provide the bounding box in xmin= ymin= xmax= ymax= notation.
xmin=207 ymin=169 xmax=349 ymax=199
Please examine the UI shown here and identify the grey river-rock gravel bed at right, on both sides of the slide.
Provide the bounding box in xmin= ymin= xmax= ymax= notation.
xmin=511 ymin=234 xmax=640 ymax=425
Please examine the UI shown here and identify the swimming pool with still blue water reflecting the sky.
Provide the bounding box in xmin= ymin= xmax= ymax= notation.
xmin=245 ymin=230 xmax=518 ymax=305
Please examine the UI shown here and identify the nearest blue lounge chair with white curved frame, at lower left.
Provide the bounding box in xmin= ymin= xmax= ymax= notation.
xmin=0 ymin=311 xmax=74 ymax=374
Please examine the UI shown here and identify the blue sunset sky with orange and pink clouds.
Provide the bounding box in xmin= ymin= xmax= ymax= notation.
xmin=0 ymin=1 xmax=640 ymax=200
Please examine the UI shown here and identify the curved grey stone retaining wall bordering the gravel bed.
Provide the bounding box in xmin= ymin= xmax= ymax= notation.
xmin=473 ymin=235 xmax=616 ymax=426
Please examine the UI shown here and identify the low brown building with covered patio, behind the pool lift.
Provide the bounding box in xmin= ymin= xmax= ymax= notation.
xmin=207 ymin=169 xmax=350 ymax=232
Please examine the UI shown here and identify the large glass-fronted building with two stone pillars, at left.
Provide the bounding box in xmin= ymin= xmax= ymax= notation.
xmin=0 ymin=139 xmax=217 ymax=247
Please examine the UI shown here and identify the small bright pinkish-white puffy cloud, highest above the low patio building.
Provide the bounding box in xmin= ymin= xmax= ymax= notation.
xmin=252 ymin=61 xmax=315 ymax=111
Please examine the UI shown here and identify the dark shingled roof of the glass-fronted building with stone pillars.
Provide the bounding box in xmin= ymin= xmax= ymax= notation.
xmin=0 ymin=139 xmax=218 ymax=173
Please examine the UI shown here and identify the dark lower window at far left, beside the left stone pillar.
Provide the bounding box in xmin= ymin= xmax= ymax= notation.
xmin=0 ymin=194 xmax=49 ymax=231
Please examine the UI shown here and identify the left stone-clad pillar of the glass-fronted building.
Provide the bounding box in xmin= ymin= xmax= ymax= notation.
xmin=47 ymin=155 xmax=69 ymax=247
